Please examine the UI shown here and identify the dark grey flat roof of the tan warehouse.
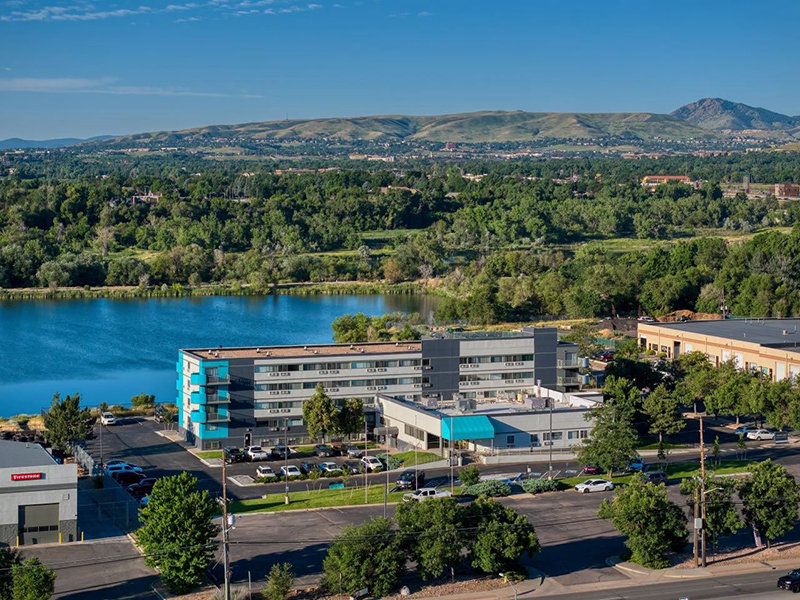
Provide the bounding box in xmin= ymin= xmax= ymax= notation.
xmin=642 ymin=319 xmax=800 ymax=347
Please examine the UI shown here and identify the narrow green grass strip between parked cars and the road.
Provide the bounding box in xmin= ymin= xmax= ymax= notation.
xmin=231 ymin=484 xmax=404 ymax=513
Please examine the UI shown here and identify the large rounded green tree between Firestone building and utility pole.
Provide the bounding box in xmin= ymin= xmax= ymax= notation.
xmin=136 ymin=471 xmax=219 ymax=594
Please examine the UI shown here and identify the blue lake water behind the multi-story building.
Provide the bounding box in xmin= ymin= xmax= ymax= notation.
xmin=0 ymin=296 xmax=432 ymax=416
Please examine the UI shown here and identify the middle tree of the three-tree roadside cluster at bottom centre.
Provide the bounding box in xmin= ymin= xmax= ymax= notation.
xmin=396 ymin=498 xmax=466 ymax=580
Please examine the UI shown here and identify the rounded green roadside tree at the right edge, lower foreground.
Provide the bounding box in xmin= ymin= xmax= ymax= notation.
xmin=739 ymin=459 xmax=800 ymax=546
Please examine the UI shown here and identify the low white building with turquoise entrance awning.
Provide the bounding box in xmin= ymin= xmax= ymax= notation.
xmin=375 ymin=386 xmax=602 ymax=456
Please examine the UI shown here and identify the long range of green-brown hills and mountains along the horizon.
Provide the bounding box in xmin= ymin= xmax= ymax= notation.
xmin=0 ymin=98 xmax=800 ymax=149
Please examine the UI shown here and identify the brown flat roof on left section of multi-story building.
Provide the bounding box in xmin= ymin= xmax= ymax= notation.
xmin=181 ymin=342 xmax=422 ymax=360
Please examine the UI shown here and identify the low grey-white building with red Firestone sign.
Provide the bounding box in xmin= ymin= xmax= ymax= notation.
xmin=0 ymin=440 xmax=78 ymax=546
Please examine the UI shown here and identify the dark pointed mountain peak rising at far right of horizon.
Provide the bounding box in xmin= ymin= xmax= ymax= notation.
xmin=670 ymin=98 xmax=800 ymax=131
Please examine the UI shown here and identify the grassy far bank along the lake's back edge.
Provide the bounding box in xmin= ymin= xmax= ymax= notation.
xmin=0 ymin=281 xmax=434 ymax=302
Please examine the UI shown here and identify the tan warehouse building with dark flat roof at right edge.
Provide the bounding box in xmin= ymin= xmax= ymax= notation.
xmin=638 ymin=319 xmax=800 ymax=381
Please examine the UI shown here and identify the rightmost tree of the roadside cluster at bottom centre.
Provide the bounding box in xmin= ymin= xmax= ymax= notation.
xmin=464 ymin=497 xmax=541 ymax=573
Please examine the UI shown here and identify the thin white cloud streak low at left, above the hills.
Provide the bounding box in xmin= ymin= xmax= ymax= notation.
xmin=0 ymin=77 xmax=261 ymax=99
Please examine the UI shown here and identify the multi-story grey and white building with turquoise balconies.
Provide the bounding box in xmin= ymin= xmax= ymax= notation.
xmin=176 ymin=327 xmax=585 ymax=449
